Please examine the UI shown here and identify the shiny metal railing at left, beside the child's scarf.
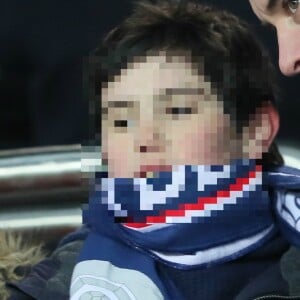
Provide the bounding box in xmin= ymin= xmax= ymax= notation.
xmin=0 ymin=145 xmax=88 ymax=243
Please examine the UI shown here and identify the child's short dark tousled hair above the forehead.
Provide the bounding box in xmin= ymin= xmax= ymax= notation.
xmin=86 ymin=0 xmax=283 ymax=165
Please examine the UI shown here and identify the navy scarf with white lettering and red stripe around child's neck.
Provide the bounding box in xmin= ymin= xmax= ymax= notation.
xmin=71 ymin=160 xmax=300 ymax=300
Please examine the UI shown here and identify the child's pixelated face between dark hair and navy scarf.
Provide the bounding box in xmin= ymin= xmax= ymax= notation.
xmin=102 ymin=52 xmax=253 ymax=177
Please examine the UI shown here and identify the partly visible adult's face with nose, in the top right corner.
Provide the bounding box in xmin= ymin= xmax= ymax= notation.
xmin=249 ymin=0 xmax=300 ymax=76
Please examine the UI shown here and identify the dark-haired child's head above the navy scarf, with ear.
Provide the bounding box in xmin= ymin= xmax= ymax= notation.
xmin=91 ymin=1 xmax=281 ymax=177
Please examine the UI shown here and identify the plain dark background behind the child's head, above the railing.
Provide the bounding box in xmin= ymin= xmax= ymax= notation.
xmin=0 ymin=0 xmax=300 ymax=149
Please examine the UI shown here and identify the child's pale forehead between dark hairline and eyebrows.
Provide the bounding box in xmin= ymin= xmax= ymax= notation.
xmin=102 ymin=50 xmax=211 ymax=97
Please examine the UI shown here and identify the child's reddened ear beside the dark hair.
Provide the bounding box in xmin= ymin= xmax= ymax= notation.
xmin=243 ymin=102 xmax=279 ymax=159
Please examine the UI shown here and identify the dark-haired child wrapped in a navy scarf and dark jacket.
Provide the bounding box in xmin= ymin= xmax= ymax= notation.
xmin=7 ymin=1 xmax=300 ymax=300
